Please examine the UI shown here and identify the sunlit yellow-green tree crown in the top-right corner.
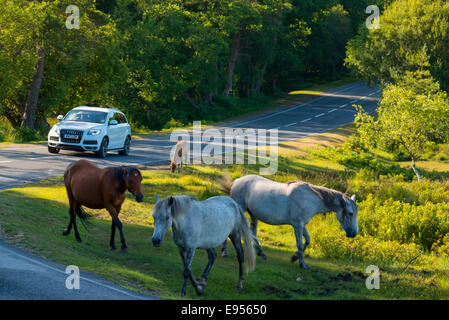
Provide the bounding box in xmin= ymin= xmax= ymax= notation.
xmin=345 ymin=0 xmax=449 ymax=90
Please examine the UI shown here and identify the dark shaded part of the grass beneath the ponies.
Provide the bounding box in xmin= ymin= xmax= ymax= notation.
xmin=0 ymin=190 xmax=444 ymax=299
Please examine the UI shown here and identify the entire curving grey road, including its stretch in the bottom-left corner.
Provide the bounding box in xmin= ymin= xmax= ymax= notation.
xmin=0 ymin=82 xmax=380 ymax=300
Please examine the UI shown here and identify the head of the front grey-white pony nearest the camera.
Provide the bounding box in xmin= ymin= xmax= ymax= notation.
xmin=151 ymin=195 xmax=175 ymax=247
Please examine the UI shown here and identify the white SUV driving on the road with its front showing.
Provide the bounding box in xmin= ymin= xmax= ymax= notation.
xmin=48 ymin=106 xmax=131 ymax=158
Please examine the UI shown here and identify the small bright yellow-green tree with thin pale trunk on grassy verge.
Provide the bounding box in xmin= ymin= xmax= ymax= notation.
xmin=355 ymin=70 xmax=449 ymax=181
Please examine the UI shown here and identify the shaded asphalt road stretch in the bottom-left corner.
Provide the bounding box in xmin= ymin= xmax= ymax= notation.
xmin=0 ymin=240 xmax=158 ymax=300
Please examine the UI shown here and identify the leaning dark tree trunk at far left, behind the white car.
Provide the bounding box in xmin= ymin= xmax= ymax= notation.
xmin=21 ymin=48 xmax=45 ymax=129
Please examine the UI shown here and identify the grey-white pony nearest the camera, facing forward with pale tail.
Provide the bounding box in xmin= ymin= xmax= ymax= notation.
xmin=151 ymin=195 xmax=256 ymax=297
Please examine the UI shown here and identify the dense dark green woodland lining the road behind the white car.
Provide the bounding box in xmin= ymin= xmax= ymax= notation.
xmin=0 ymin=0 xmax=383 ymax=132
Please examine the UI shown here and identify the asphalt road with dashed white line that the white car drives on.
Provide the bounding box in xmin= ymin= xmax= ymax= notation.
xmin=0 ymin=82 xmax=380 ymax=190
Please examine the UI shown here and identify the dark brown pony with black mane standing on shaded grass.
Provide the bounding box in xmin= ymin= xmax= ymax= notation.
xmin=62 ymin=160 xmax=143 ymax=252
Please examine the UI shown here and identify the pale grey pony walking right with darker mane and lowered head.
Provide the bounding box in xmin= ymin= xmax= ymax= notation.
xmin=220 ymin=174 xmax=358 ymax=268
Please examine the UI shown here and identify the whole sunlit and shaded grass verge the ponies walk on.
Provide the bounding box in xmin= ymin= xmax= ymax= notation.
xmin=0 ymin=126 xmax=449 ymax=299
